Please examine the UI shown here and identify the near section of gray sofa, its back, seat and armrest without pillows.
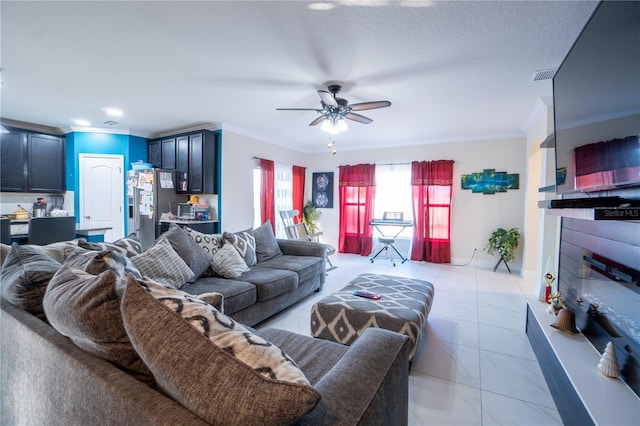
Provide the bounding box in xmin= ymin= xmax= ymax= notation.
xmin=0 ymin=300 xmax=409 ymax=426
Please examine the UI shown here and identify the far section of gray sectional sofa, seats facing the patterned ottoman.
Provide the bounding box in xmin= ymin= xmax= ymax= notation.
xmin=158 ymin=223 xmax=326 ymax=326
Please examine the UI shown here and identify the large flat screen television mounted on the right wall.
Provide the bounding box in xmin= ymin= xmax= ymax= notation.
xmin=553 ymin=1 xmax=640 ymax=194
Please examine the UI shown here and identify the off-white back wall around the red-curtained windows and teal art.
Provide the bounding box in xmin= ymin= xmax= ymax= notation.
xmin=222 ymin=126 xmax=527 ymax=270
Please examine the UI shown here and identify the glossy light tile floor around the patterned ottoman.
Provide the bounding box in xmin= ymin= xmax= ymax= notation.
xmin=257 ymin=254 xmax=562 ymax=426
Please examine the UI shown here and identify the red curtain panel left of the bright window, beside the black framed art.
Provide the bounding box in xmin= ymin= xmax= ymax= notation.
xmin=338 ymin=164 xmax=376 ymax=256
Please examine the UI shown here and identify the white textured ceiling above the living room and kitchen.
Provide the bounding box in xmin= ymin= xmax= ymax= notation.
xmin=0 ymin=0 xmax=597 ymax=152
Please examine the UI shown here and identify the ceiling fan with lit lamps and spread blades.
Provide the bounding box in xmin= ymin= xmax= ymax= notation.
xmin=276 ymin=84 xmax=391 ymax=134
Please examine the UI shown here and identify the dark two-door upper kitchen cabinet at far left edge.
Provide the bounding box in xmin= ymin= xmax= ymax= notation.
xmin=0 ymin=130 xmax=66 ymax=193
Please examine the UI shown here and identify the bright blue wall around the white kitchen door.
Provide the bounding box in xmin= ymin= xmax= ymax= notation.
xmin=65 ymin=132 xmax=147 ymax=234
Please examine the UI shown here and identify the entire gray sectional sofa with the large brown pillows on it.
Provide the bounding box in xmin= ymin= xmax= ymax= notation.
xmin=0 ymin=225 xmax=409 ymax=425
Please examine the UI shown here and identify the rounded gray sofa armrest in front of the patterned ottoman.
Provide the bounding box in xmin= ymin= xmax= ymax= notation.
xmin=300 ymin=328 xmax=409 ymax=425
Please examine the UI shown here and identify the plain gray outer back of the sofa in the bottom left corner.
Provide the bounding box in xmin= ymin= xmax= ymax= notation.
xmin=0 ymin=299 xmax=206 ymax=426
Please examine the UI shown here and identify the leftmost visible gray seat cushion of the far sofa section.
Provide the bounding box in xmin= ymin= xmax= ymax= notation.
xmin=180 ymin=277 xmax=257 ymax=315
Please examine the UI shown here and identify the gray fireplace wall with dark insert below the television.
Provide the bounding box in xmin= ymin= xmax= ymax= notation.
xmin=558 ymin=211 xmax=640 ymax=396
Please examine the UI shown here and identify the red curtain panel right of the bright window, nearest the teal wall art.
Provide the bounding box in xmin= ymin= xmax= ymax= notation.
xmin=411 ymin=160 xmax=453 ymax=263
